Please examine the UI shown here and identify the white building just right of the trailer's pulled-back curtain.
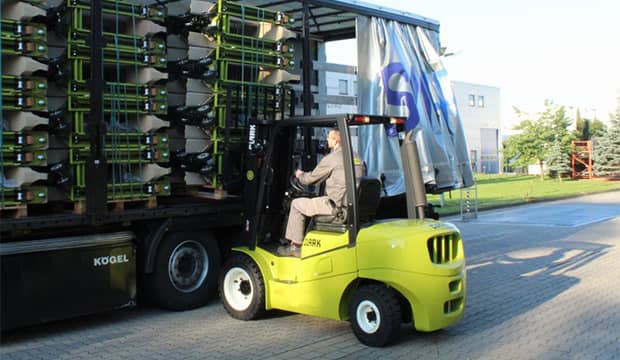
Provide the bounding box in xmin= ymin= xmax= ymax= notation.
xmin=452 ymin=81 xmax=502 ymax=174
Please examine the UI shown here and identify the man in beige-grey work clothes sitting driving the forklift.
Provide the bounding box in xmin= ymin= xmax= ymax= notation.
xmin=278 ymin=128 xmax=363 ymax=257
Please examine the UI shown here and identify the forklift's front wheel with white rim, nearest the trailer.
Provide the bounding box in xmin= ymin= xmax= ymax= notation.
xmin=219 ymin=254 xmax=265 ymax=320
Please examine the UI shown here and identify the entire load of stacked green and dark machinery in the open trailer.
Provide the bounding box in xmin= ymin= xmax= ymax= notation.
xmin=0 ymin=0 xmax=299 ymax=217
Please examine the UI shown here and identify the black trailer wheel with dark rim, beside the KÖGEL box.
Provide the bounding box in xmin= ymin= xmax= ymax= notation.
xmin=147 ymin=233 xmax=221 ymax=310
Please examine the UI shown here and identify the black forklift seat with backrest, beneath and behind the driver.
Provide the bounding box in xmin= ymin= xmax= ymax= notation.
xmin=312 ymin=176 xmax=381 ymax=233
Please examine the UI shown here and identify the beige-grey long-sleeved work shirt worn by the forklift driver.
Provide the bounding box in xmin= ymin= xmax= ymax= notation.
xmin=299 ymin=146 xmax=363 ymax=207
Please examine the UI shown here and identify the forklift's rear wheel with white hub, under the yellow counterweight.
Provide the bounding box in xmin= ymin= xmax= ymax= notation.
xmin=349 ymin=284 xmax=402 ymax=347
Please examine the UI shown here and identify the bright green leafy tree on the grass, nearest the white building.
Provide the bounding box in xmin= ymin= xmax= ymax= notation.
xmin=504 ymin=100 xmax=574 ymax=179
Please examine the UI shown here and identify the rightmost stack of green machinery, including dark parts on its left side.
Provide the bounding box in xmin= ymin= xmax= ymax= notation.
xmin=168 ymin=0 xmax=299 ymax=196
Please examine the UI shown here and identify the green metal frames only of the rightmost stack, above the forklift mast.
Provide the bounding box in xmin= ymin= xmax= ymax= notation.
xmin=210 ymin=0 xmax=295 ymax=190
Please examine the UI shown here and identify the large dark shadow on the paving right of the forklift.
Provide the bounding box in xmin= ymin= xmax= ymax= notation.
xmin=450 ymin=224 xmax=611 ymax=334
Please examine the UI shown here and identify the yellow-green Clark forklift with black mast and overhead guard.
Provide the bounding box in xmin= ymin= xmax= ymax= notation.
xmin=219 ymin=115 xmax=466 ymax=346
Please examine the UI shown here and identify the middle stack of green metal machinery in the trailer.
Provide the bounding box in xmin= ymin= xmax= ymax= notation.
xmin=66 ymin=0 xmax=171 ymax=209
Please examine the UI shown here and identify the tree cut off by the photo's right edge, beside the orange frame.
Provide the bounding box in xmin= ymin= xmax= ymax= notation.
xmin=593 ymin=97 xmax=620 ymax=176
